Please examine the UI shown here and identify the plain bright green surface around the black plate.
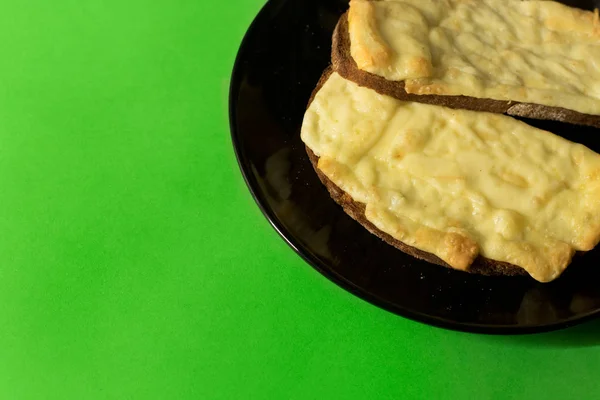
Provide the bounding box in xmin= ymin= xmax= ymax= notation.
xmin=0 ymin=0 xmax=600 ymax=399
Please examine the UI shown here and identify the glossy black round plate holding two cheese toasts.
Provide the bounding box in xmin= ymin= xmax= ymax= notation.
xmin=230 ymin=0 xmax=600 ymax=333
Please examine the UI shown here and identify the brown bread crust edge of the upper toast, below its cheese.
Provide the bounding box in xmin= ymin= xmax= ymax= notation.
xmin=331 ymin=13 xmax=600 ymax=128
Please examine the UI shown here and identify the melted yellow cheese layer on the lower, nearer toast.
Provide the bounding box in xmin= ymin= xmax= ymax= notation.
xmin=301 ymin=73 xmax=600 ymax=282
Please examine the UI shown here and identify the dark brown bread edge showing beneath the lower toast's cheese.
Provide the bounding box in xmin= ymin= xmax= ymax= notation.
xmin=306 ymin=67 xmax=528 ymax=275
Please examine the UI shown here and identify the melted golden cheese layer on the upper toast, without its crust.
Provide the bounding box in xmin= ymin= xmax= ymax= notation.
xmin=348 ymin=0 xmax=600 ymax=115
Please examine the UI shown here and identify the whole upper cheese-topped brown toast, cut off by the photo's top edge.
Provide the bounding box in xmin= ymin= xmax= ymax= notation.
xmin=332 ymin=0 xmax=600 ymax=127
